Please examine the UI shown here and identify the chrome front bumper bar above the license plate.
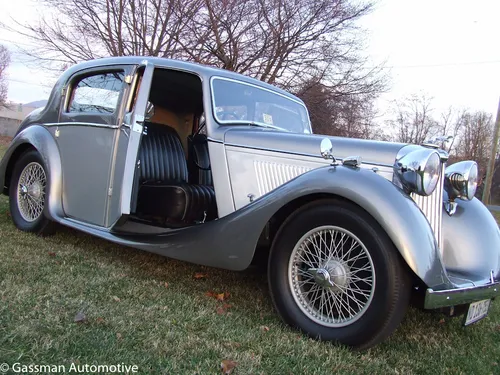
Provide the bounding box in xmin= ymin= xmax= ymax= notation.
xmin=424 ymin=282 xmax=500 ymax=309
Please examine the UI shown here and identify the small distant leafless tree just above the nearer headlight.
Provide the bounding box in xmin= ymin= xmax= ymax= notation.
xmin=387 ymin=94 xmax=439 ymax=144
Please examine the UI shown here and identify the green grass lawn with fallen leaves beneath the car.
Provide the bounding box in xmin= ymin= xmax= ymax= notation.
xmin=0 ymin=139 xmax=500 ymax=374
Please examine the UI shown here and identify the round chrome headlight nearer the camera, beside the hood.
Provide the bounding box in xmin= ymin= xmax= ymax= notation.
xmin=394 ymin=149 xmax=441 ymax=195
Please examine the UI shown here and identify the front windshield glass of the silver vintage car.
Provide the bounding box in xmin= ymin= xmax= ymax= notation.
xmin=212 ymin=78 xmax=311 ymax=133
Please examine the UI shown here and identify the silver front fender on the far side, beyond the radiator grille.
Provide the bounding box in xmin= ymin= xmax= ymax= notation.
xmin=442 ymin=198 xmax=500 ymax=283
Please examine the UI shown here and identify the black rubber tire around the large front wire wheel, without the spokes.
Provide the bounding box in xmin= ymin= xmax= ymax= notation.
xmin=268 ymin=200 xmax=411 ymax=349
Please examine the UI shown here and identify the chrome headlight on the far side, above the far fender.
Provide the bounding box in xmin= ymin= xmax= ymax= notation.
xmin=444 ymin=161 xmax=479 ymax=201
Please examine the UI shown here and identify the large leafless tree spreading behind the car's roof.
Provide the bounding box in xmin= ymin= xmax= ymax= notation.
xmin=0 ymin=0 xmax=385 ymax=96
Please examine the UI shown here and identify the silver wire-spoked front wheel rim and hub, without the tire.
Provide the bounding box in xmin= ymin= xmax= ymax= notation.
xmin=288 ymin=226 xmax=375 ymax=327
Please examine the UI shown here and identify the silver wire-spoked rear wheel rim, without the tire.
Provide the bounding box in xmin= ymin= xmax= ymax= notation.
xmin=17 ymin=162 xmax=47 ymax=222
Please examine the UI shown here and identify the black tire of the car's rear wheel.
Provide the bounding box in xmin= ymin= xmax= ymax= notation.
xmin=9 ymin=150 xmax=55 ymax=236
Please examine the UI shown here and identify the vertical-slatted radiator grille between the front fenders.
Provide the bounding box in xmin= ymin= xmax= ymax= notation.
xmin=411 ymin=164 xmax=445 ymax=251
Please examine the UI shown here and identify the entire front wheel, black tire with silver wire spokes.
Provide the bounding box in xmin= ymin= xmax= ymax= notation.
xmin=268 ymin=200 xmax=410 ymax=349
